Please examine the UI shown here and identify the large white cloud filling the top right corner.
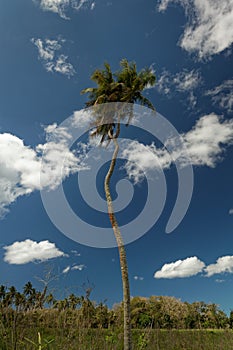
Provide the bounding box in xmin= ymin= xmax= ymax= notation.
xmin=158 ymin=0 xmax=233 ymax=59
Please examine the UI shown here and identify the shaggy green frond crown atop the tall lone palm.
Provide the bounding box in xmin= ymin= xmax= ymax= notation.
xmin=81 ymin=59 xmax=156 ymax=143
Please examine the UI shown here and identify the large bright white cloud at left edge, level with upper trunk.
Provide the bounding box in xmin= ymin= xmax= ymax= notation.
xmin=0 ymin=124 xmax=86 ymax=217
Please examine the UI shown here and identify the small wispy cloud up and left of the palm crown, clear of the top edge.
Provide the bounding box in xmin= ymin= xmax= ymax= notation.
xmin=31 ymin=37 xmax=76 ymax=77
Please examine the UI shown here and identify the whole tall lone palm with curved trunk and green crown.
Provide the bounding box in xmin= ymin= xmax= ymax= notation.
xmin=82 ymin=59 xmax=155 ymax=350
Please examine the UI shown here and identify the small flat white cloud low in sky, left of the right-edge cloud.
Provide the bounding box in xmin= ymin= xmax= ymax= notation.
xmin=154 ymin=256 xmax=205 ymax=279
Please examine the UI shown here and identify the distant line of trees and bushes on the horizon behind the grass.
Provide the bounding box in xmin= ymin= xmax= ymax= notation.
xmin=0 ymin=282 xmax=233 ymax=329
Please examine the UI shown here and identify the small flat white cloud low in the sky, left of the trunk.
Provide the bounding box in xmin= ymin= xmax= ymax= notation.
xmin=4 ymin=239 xmax=65 ymax=265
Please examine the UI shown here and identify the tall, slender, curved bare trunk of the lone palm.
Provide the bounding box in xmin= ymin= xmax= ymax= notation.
xmin=104 ymin=137 xmax=132 ymax=350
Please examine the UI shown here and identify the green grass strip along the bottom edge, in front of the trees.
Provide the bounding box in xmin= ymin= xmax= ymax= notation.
xmin=0 ymin=328 xmax=233 ymax=350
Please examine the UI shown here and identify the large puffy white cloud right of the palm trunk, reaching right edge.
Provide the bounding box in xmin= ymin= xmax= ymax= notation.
xmin=122 ymin=113 xmax=233 ymax=182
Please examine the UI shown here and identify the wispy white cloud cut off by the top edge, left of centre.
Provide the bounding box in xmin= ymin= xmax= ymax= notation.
xmin=38 ymin=0 xmax=95 ymax=19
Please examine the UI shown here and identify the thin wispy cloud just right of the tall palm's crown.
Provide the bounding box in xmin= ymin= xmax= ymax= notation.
xmin=156 ymin=69 xmax=202 ymax=107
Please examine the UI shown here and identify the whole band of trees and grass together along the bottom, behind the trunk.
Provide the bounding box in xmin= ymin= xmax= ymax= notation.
xmin=0 ymin=284 xmax=233 ymax=350
